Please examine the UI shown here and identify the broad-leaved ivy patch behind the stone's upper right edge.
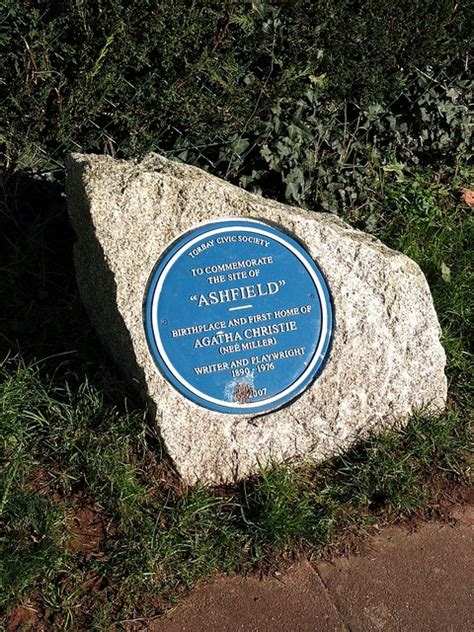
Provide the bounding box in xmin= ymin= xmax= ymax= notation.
xmin=235 ymin=68 xmax=473 ymax=220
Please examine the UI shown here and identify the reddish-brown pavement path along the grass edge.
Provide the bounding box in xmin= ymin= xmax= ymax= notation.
xmin=153 ymin=505 xmax=474 ymax=632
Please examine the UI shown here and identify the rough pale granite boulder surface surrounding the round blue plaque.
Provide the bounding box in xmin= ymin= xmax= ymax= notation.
xmin=67 ymin=154 xmax=447 ymax=484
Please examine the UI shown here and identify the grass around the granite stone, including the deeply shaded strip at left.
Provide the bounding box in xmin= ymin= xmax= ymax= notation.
xmin=0 ymin=169 xmax=473 ymax=629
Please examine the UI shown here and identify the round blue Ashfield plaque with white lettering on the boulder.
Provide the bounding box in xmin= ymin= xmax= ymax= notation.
xmin=144 ymin=219 xmax=333 ymax=415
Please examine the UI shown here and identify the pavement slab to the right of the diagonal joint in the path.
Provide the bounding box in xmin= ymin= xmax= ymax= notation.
xmin=317 ymin=507 xmax=474 ymax=632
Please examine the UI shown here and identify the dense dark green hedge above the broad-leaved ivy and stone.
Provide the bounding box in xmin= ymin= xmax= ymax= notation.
xmin=0 ymin=0 xmax=472 ymax=174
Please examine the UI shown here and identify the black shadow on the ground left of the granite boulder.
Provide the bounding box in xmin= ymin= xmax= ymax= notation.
xmin=0 ymin=173 xmax=143 ymax=405
